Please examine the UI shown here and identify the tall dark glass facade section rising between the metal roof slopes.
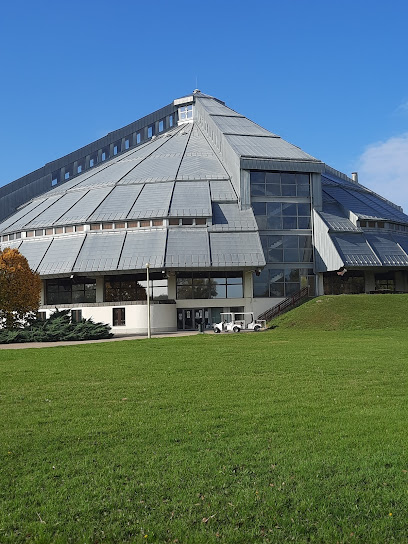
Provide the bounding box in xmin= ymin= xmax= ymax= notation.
xmin=250 ymin=171 xmax=314 ymax=298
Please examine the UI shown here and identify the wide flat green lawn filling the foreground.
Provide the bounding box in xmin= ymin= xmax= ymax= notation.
xmin=0 ymin=301 xmax=408 ymax=544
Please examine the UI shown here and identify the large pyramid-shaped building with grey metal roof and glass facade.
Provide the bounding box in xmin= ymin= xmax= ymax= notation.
xmin=0 ymin=90 xmax=408 ymax=332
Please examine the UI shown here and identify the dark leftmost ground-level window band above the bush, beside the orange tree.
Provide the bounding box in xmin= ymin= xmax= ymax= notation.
xmin=46 ymin=276 xmax=96 ymax=304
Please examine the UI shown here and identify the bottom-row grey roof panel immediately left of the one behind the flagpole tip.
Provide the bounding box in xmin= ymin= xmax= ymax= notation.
xmin=73 ymin=232 xmax=126 ymax=272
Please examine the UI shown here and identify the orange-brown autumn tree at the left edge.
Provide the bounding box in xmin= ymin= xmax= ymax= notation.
xmin=0 ymin=247 xmax=41 ymax=329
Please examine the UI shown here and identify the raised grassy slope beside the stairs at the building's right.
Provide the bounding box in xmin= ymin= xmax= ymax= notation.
xmin=271 ymin=295 xmax=408 ymax=330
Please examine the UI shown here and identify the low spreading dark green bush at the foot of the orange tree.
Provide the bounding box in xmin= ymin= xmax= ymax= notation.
xmin=0 ymin=309 xmax=113 ymax=344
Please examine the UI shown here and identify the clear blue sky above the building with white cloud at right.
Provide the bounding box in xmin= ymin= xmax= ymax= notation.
xmin=0 ymin=0 xmax=408 ymax=211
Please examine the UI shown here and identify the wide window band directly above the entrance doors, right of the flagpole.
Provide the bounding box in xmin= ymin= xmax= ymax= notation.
xmin=177 ymin=272 xmax=243 ymax=299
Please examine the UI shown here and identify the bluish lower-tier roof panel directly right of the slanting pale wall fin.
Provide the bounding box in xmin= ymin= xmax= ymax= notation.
xmin=330 ymin=233 xmax=381 ymax=266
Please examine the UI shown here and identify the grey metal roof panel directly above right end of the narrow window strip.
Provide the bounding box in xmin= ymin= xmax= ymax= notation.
xmin=169 ymin=181 xmax=211 ymax=217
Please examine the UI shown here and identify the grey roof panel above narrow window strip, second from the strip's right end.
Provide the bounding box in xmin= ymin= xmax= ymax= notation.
xmin=127 ymin=181 xmax=174 ymax=219
